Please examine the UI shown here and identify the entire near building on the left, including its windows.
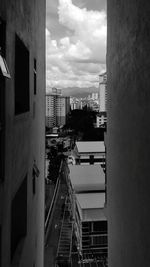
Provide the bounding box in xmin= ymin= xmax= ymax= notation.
xmin=0 ymin=0 xmax=45 ymax=267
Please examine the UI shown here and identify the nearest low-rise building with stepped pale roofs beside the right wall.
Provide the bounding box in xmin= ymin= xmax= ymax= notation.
xmin=69 ymin=165 xmax=107 ymax=264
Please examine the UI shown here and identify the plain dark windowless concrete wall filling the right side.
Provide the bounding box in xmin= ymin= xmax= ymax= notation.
xmin=107 ymin=0 xmax=150 ymax=267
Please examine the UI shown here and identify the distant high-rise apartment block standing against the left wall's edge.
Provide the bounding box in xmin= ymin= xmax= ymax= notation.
xmin=46 ymin=91 xmax=70 ymax=128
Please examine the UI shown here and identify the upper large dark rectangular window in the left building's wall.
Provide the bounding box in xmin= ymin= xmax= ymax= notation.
xmin=15 ymin=35 xmax=30 ymax=115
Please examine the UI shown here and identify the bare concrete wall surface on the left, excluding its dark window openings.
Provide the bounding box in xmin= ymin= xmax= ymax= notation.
xmin=0 ymin=0 xmax=45 ymax=267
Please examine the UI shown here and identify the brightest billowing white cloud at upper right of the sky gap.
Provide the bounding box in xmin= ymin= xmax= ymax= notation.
xmin=58 ymin=0 xmax=106 ymax=62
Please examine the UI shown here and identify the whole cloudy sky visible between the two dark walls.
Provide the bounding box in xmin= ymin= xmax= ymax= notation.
xmin=46 ymin=0 xmax=107 ymax=95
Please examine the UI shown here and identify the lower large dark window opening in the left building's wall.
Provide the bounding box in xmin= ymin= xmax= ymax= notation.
xmin=11 ymin=176 xmax=27 ymax=260
